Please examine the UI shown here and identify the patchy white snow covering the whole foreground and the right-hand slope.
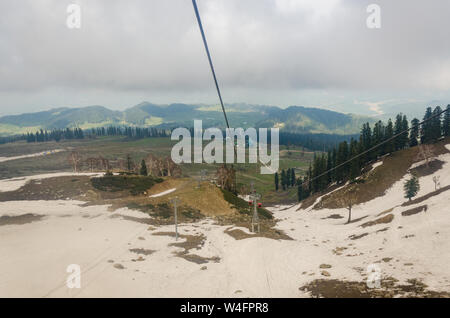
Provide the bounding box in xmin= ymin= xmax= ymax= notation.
xmin=0 ymin=146 xmax=450 ymax=297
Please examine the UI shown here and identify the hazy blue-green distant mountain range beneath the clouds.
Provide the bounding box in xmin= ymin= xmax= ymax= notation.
xmin=0 ymin=102 xmax=374 ymax=136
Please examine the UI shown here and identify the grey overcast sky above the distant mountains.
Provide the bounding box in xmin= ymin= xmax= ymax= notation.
xmin=0 ymin=0 xmax=450 ymax=115
